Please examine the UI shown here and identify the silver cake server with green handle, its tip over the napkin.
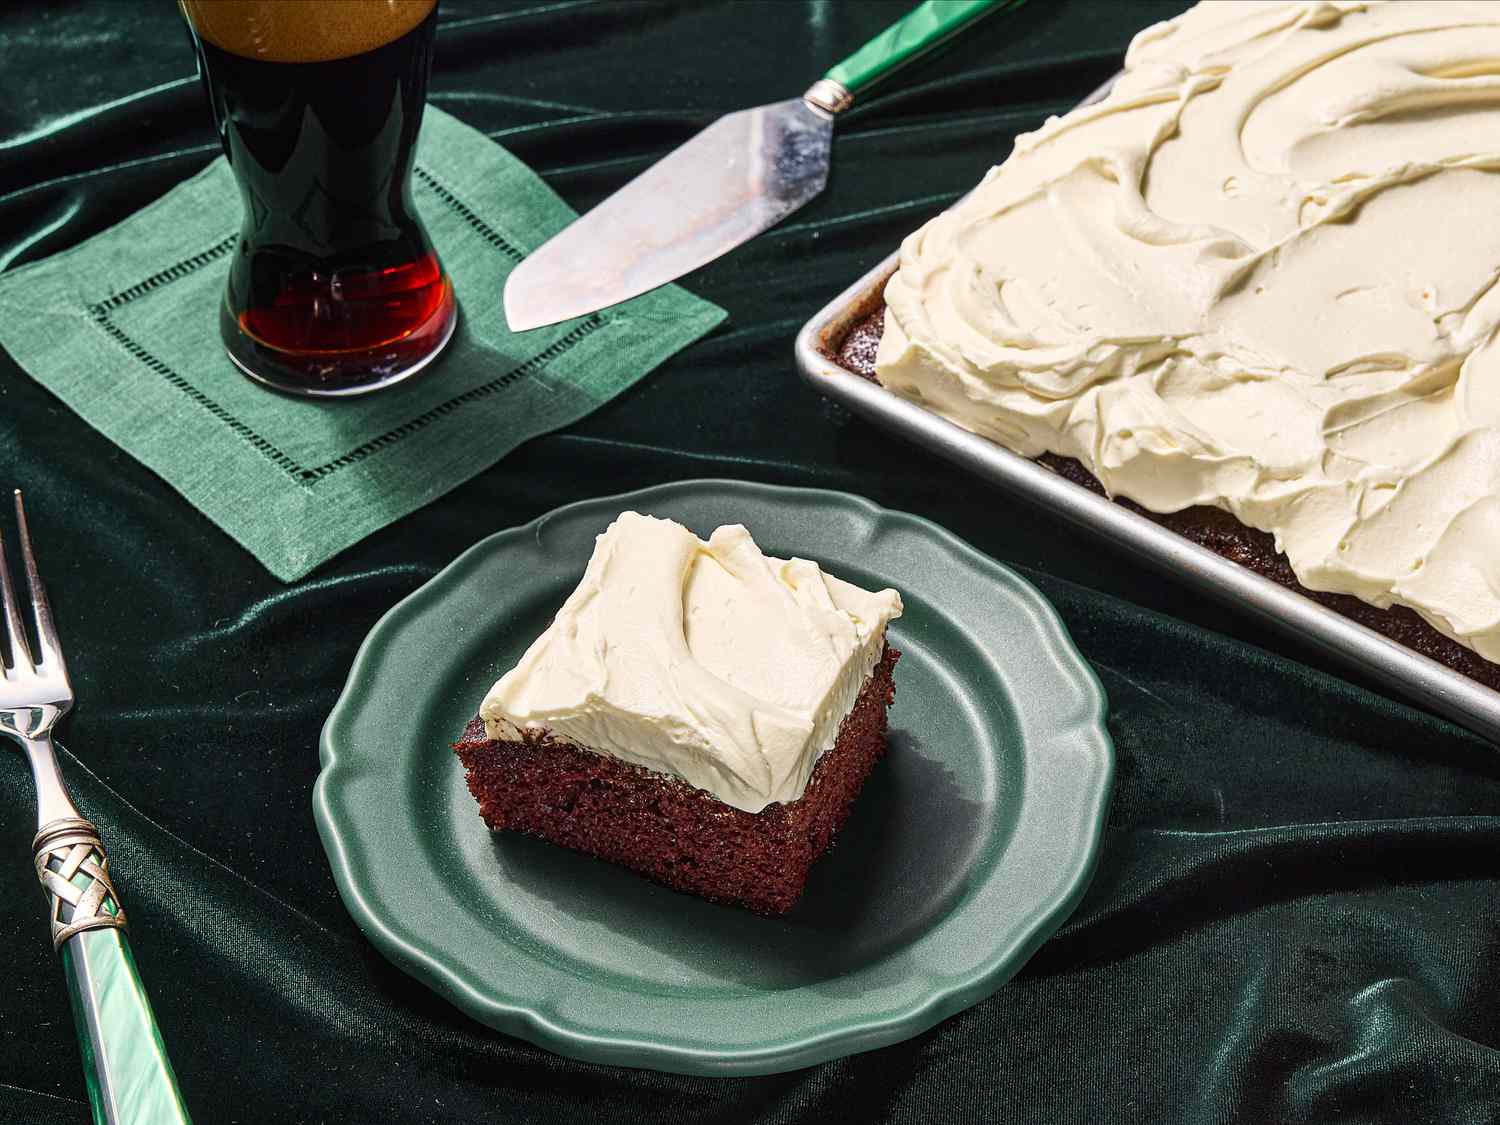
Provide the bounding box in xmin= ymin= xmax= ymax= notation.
xmin=506 ymin=0 xmax=1022 ymax=332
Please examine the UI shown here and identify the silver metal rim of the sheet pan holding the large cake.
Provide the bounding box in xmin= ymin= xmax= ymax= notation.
xmin=795 ymin=80 xmax=1500 ymax=741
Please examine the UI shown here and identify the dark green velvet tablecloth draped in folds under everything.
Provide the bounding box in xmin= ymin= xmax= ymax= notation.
xmin=0 ymin=0 xmax=1500 ymax=1125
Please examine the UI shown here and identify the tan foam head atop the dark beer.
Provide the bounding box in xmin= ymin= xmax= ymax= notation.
xmin=179 ymin=0 xmax=438 ymax=63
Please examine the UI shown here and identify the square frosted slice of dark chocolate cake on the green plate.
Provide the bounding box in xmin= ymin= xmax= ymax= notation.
xmin=453 ymin=513 xmax=900 ymax=915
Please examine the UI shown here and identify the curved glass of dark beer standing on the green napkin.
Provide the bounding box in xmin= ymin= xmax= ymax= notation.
xmin=179 ymin=0 xmax=458 ymax=396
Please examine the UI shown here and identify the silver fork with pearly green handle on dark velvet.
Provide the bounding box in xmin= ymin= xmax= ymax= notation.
xmin=0 ymin=489 xmax=188 ymax=1125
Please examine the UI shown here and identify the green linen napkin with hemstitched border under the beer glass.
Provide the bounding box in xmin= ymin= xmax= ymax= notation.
xmin=0 ymin=107 xmax=725 ymax=582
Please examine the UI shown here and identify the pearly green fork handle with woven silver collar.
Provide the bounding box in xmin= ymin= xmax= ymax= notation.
xmin=33 ymin=818 xmax=189 ymax=1125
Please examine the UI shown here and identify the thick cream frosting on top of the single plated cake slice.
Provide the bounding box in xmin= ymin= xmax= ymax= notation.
xmin=480 ymin=512 xmax=902 ymax=813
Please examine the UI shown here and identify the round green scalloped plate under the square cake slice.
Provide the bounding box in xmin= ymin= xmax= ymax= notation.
xmin=314 ymin=480 xmax=1113 ymax=1074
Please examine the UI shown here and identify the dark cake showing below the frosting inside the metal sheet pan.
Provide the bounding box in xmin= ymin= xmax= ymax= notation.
xmin=830 ymin=305 xmax=1500 ymax=690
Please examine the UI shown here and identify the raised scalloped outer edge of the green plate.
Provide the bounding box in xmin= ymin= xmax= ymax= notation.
xmin=312 ymin=479 xmax=1115 ymax=1077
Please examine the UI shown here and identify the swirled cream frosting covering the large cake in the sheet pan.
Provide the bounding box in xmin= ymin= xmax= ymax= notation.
xmin=876 ymin=0 xmax=1500 ymax=660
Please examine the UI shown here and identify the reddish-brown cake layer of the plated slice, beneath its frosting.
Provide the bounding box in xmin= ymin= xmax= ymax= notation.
xmin=453 ymin=645 xmax=900 ymax=915
